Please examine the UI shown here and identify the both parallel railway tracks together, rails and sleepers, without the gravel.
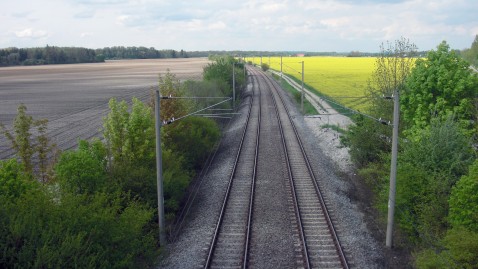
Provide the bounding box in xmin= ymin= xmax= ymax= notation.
xmin=204 ymin=65 xmax=349 ymax=268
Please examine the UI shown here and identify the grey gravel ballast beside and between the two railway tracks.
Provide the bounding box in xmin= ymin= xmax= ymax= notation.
xmin=159 ymin=70 xmax=383 ymax=268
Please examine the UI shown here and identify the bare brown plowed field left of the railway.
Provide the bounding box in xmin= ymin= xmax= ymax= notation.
xmin=0 ymin=58 xmax=208 ymax=160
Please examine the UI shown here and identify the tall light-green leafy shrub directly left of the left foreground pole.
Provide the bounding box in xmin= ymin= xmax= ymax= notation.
xmin=102 ymin=98 xmax=156 ymax=206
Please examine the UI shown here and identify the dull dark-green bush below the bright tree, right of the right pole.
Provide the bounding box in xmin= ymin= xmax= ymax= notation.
xmin=392 ymin=119 xmax=473 ymax=243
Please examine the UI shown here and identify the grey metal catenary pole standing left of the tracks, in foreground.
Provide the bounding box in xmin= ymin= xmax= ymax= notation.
xmin=155 ymin=90 xmax=166 ymax=246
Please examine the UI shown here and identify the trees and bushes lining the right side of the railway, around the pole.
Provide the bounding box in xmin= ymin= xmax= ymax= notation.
xmin=342 ymin=39 xmax=478 ymax=268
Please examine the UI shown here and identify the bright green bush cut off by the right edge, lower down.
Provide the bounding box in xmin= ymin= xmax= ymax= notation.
xmin=449 ymin=160 xmax=478 ymax=230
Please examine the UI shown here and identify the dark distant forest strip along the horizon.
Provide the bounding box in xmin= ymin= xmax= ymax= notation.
xmin=0 ymin=41 xmax=478 ymax=67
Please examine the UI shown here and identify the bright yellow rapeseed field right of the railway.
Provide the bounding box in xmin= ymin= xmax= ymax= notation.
xmin=246 ymin=57 xmax=376 ymax=110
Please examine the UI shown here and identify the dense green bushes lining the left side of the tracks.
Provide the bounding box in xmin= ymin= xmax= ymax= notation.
xmin=0 ymin=54 xmax=241 ymax=268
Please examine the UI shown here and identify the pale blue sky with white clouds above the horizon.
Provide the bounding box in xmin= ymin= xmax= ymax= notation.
xmin=0 ymin=0 xmax=478 ymax=52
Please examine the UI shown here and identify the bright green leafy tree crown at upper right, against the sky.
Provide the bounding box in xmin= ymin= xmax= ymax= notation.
xmin=400 ymin=42 xmax=478 ymax=137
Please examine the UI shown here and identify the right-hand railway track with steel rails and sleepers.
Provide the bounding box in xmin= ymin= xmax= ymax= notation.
xmin=254 ymin=67 xmax=349 ymax=268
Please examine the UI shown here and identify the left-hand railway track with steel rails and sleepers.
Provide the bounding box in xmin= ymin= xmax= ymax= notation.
xmin=204 ymin=72 xmax=261 ymax=268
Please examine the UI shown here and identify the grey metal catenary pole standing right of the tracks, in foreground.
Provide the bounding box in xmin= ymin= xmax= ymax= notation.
xmin=386 ymin=89 xmax=400 ymax=248
